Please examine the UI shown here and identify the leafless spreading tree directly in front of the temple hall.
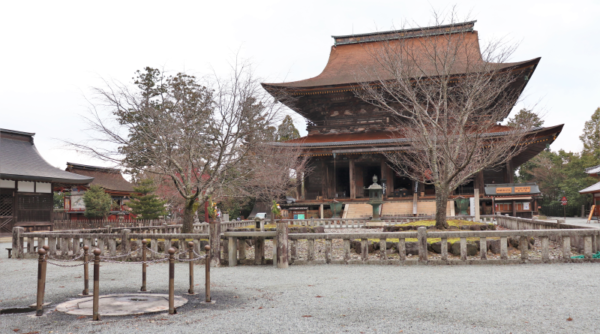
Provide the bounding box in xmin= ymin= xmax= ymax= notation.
xmin=355 ymin=13 xmax=531 ymax=228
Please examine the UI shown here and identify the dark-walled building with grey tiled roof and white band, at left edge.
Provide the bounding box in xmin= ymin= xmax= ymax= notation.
xmin=0 ymin=129 xmax=94 ymax=233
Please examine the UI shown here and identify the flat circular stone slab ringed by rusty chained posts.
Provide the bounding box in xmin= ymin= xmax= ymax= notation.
xmin=56 ymin=294 xmax=187 ymax=316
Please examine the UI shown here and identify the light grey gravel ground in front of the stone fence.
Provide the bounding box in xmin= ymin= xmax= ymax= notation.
xmin=0 ymin=252 xmax=600 ymax=333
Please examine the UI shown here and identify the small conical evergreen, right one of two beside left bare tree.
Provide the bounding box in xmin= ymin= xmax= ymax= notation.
xmin=127 ymin=179 xmax=167 ymax=219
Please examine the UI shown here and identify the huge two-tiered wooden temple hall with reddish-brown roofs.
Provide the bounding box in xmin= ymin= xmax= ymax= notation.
xmin=262 ymin=21 xmax=563 ymax=218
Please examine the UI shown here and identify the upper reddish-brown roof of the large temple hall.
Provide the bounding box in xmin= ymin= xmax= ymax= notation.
xmin=263 ymin=21 xmax=540 ymax=95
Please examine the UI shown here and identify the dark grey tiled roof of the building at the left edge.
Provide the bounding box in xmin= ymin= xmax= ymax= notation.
xmin=0 ymin=129 xmax=93 ymax=184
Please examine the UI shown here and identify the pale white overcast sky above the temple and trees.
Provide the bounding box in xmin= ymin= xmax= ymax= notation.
xmin=0 ymin=0 xmax=600 ymax=168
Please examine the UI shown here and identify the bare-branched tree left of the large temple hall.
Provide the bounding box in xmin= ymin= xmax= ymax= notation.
xmin=70 ymin=63 xmax=281 ymax=233
